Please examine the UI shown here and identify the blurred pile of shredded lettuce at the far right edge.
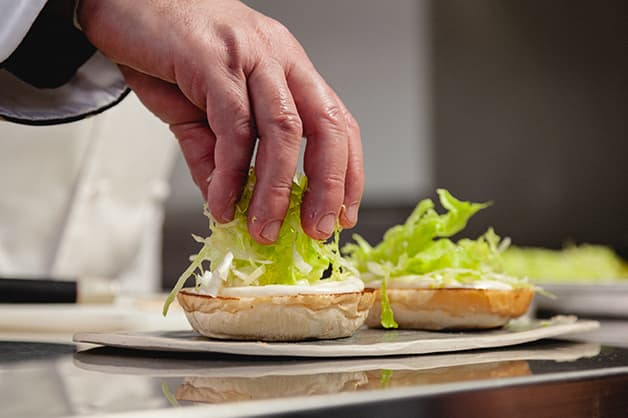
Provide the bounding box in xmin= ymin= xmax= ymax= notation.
xmin=502 ymin=244 xmax=628 ymax=283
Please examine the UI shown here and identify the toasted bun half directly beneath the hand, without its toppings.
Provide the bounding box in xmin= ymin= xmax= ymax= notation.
xmin=177 ymin=289 xmax=375 ymax=341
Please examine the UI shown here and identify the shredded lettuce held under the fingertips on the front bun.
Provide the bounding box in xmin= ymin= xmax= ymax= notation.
xmin=163 ymin=168 xmax=357 ymax=315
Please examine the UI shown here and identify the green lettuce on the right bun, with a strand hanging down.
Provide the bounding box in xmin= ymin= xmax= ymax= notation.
xmin=343 ymin=189 xmax=530 ymax=328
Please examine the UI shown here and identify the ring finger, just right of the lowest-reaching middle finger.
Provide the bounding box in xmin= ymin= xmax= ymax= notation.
xmin=288 ymin=66 xmax=350 ymax=239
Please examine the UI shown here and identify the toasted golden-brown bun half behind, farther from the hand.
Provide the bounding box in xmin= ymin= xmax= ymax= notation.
xmin=366 ymin=288 xmax=534 ymax=330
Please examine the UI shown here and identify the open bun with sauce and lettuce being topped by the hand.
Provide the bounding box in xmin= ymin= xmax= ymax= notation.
xmin=164 ymin=169 xmax=375 ymax=341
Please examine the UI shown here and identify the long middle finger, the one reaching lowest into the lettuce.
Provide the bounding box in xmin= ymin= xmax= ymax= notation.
xmin=248 ymin=61 xmax=302 ymax=243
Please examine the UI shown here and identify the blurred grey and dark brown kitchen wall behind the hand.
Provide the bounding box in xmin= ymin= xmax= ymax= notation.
xmin=162 ymin=0 xmax=628 ymax=288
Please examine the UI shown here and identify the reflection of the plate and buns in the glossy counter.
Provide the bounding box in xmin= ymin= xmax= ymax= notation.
xmin=74 ymin=342 xmax=600 ymax=405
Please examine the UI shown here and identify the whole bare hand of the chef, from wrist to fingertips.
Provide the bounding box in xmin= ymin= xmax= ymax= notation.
xmin=78 ymin=0 xmax=364 ymax=243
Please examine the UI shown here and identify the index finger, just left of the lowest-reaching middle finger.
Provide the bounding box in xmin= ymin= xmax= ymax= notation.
xmin=207 ymin=74 xmax=256 ymax=223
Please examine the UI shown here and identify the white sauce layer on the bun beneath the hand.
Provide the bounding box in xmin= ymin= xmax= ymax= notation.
xmin=195 ymin=277 xmax=364 ymax=297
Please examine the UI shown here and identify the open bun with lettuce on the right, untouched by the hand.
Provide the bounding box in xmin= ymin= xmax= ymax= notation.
xmin=343 ymin=189 xmax=535 ymax=330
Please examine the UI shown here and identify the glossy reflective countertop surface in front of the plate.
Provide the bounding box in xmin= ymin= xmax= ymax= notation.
xmin=0 ymin=340 xmax=628 ymax=418
